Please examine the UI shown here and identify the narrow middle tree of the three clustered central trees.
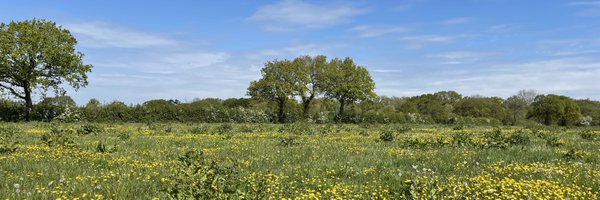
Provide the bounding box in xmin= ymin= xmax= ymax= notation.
xmin=294 ymin=55 xmax=327 ymax=118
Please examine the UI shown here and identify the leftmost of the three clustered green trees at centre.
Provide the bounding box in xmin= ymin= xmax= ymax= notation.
xmin=248 ymin=60 xmax=298 ymax=123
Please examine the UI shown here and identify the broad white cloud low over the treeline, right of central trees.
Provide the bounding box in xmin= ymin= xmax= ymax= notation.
xmin=374 ymin=57 xmax=600 ymax=100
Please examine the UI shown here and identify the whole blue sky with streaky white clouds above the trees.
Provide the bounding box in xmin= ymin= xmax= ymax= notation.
xmin=0 ymin=0 xmax=600 ymax=104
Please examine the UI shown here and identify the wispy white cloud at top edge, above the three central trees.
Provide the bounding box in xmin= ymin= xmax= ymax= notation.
xmin=247 ymin=0 xmax=367 ymax=31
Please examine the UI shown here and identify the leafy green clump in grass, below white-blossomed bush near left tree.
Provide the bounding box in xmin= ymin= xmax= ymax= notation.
xmin=42 ymin=125 xmax=76 ymax=148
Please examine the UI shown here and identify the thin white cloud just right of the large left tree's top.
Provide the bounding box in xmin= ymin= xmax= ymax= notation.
xmin=64 ymin=22 xmax=177 ymax=48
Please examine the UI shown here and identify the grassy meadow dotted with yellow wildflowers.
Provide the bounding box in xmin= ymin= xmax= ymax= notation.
xmin=0 ymin=123 xmax=600 ymax=199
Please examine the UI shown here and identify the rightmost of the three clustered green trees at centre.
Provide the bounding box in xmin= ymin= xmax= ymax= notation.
xmin=321 ymin=58 xmax=377 ymax=121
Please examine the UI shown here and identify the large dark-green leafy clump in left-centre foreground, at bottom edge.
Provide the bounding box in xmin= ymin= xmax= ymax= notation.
xmin=165 ymin=150 xmax=241 ymax=199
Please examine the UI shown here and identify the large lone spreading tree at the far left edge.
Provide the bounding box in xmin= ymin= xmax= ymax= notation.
xmin=0 ymin=19 xmax=92 ymax=120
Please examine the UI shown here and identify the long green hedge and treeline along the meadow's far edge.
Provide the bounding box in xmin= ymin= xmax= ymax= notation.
xmin=0 ymin=90 xmax=600 ymax=126
